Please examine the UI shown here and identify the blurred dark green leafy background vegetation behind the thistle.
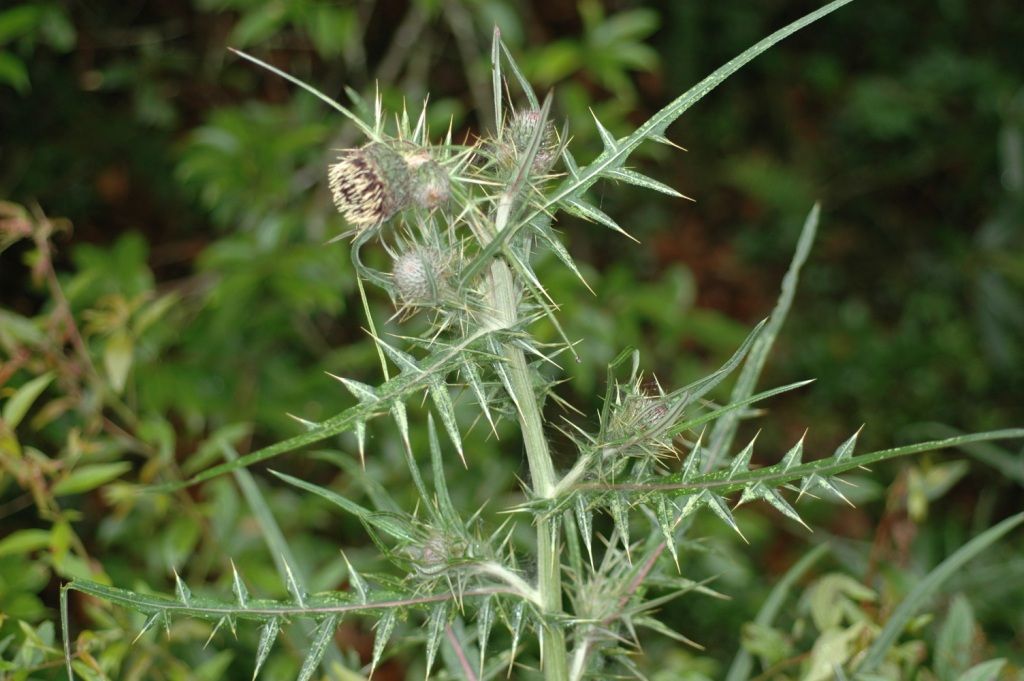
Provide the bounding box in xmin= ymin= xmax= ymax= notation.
xmin=0 ymin=0 xmax=1024 ymax=679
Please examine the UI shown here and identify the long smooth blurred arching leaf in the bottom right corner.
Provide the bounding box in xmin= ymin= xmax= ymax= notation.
xmin=857 ymin=513 xmax=1024 ymax=673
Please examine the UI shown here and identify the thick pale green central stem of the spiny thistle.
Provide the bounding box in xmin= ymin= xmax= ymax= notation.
xmin=487 ymin=195 xmax=568 ymax=681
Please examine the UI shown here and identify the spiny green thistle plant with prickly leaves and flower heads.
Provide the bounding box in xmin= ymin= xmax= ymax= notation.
xmin=61 ymin=0 xmax=1024 ymax=681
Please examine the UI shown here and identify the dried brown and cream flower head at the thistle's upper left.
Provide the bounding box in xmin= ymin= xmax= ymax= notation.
xmin=328 ymin=142 xmax=412 ymax=230
